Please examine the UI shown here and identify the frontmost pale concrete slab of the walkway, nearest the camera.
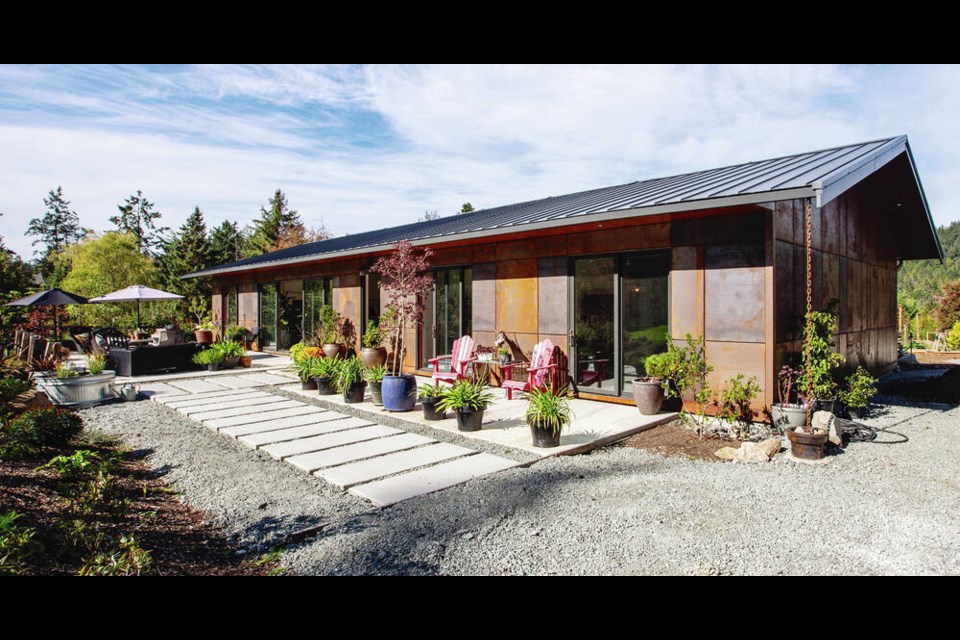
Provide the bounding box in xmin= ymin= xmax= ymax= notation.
xmin=349 ymin=453 xmax=518 ymax=507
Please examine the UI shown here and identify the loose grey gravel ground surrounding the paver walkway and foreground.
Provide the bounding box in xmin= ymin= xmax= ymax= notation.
xmin=77 ymin=402 xmax=960 ymax=574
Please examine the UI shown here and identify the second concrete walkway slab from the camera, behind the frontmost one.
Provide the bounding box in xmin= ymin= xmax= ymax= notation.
xmin=318 ymin=436 xmax=476 ymax=489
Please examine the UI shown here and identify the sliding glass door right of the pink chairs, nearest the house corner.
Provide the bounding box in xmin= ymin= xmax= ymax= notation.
xmin=570 ymin=251 xmax=670 ymax=395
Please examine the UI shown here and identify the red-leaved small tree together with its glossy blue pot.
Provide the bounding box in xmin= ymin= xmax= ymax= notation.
xmin=371 ymin=241 xmax=433 ymax=411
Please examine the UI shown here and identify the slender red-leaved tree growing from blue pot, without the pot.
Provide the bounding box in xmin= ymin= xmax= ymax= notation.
xmin=370 ymin=240 xmax=433 ymax=375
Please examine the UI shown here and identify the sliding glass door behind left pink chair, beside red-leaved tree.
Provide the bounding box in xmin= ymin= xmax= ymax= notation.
xmin=420 ymin=267 xmax=473 ymax=369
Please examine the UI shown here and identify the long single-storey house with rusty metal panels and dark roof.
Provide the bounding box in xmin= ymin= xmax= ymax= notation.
xmin=188 ymin=136 xmax=942 ymax=404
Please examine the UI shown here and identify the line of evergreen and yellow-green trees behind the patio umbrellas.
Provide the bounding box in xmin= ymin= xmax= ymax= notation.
xmin=0 ymin=186 xmax=330 ymax=326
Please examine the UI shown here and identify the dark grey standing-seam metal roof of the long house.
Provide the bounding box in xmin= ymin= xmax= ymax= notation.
xmin=186 ymin=136 xmax=932 ymax=277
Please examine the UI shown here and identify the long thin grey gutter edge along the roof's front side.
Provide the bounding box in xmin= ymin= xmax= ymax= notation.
xmin=180 ymin=186 xmax=816 ymax=280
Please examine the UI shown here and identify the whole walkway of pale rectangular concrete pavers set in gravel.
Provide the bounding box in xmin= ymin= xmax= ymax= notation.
xmin=149 ymin=372 xmax=518 ymax=506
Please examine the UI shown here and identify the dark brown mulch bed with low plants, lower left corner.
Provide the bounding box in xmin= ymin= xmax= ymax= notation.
xmin=0 ymin=444 xmax=277 ymax=575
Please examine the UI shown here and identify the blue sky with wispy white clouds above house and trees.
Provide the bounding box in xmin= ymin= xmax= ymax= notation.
xmin=0 ymin=65 xmax=960 ymax=256
